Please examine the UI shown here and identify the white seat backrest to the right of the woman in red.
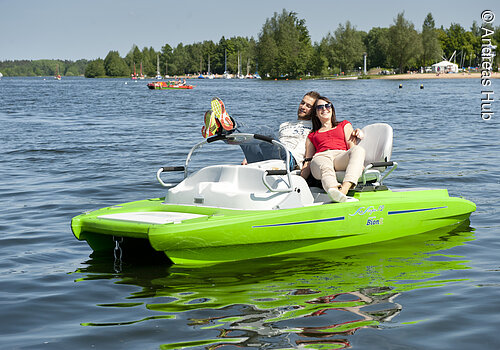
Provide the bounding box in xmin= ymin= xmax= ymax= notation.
xmin=358 ymin=123 xmax=393 ymax=166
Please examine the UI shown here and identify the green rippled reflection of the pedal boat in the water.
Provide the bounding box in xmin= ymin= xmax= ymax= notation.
xmin=76 ymin=221 xmax=474 ymax=349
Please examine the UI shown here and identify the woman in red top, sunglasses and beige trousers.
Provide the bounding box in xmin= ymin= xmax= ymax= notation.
xmin=301 ymin=96 xmax=365 ymax=202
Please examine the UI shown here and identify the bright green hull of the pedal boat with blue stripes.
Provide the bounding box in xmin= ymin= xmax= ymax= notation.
xmin=71 ymin=189 xmax=476 ymax=265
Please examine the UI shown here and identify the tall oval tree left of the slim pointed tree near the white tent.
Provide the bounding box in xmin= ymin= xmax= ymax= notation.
xmin=388 ymin=12 xmax=422 ymax=73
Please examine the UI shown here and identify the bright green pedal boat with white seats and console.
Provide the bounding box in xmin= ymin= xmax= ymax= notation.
xmin=71 ymin=123 xmax=476 ymax=265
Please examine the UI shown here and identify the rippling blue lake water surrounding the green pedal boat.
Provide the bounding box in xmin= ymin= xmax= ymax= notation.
xmin=0 ymin=77 xmax=500 ymax=349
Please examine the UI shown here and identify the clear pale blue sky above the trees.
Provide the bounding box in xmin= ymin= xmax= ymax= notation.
xmin=0 ymin=0 xmax=500 ymax=61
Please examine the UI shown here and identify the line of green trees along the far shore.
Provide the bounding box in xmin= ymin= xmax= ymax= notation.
xmin=0 ymin=9 xmax=500 ymax=78
